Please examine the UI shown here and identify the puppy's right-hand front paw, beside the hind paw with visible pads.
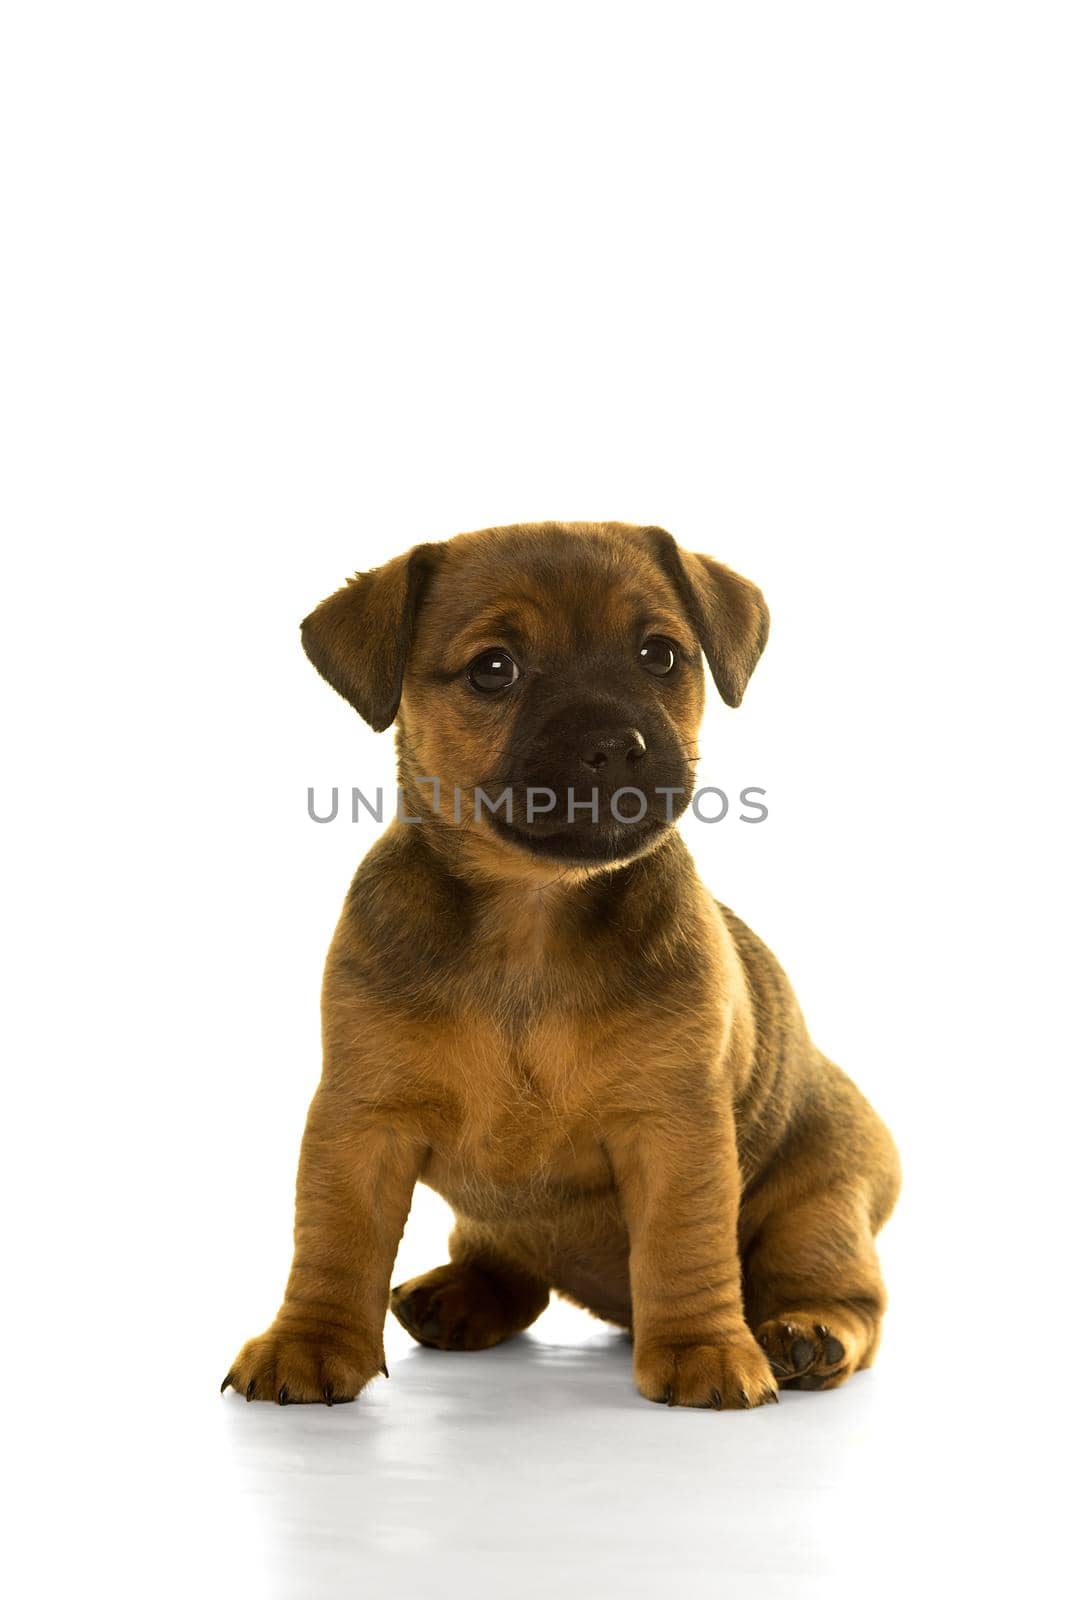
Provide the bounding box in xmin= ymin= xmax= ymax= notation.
xmin=635 ymin=1331 xmax=779 ymax=1411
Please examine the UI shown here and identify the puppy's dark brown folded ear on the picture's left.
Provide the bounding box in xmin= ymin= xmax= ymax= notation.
xmin=301 ymin=544 xmax=440 ymax=733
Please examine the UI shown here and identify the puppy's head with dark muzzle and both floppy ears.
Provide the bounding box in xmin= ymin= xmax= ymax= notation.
xmin=302 ymin=523 xmax=767 ymax=872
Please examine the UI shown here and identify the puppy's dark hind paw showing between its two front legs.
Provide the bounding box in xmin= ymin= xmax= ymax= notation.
xmin=390 ymin=1222 xmax=548 ymax=1350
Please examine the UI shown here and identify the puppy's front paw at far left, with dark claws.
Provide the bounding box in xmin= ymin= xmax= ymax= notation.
xmin=222 ymin=1322 xmax=389 ymax=1405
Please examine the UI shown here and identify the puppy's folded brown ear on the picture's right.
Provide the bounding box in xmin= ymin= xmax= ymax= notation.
xmin=646 ymin=528 xmax=771 ymax=706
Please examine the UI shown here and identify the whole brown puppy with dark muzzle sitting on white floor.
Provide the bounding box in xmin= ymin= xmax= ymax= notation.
xmin=224 ymin=523 xmax=899 ymax=1408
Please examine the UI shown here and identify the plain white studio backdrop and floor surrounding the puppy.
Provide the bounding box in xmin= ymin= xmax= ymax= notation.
xmin=0 ymin=0 xmax=1068 ymax=1600
